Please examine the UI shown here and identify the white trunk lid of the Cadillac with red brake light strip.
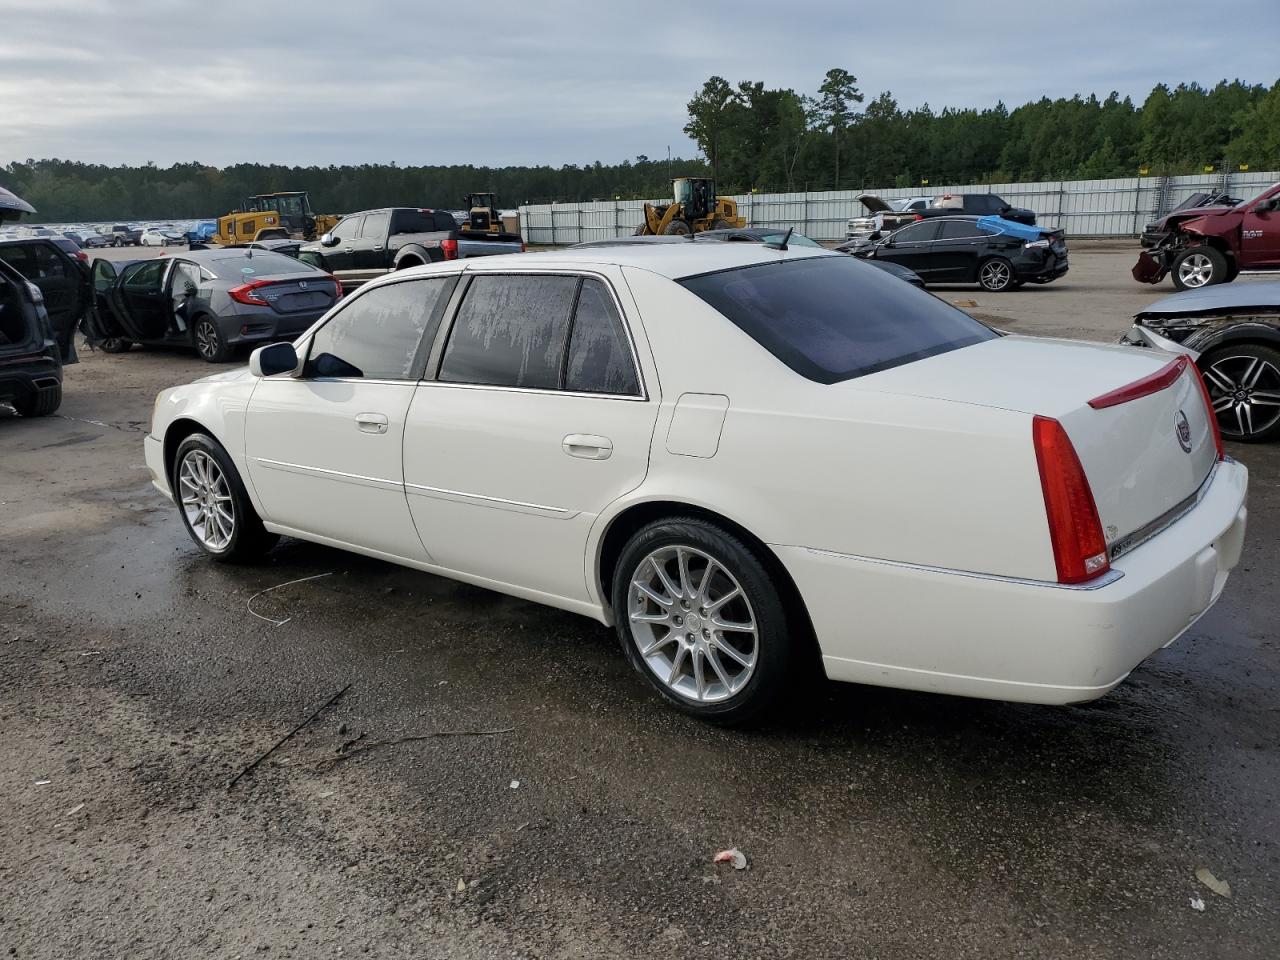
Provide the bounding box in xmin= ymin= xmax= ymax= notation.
xmin=844 ymin=337 xmax=1217 ymax=557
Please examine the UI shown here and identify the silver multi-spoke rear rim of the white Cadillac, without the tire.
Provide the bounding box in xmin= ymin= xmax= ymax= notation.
xmin=627 ymin=545 xmax=759 ymax=704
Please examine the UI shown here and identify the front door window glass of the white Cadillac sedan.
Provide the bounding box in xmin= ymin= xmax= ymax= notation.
xmin=307 ymin=276 xmax=454 ymax=380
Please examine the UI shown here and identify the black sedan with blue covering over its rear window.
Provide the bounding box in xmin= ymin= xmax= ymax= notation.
xmin=836 ymin=216 xmax=1068 ymax=293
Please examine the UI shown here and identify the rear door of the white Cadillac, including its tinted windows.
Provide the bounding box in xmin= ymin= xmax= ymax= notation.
xmin=404 ymin=273 xmax=658 ymax=600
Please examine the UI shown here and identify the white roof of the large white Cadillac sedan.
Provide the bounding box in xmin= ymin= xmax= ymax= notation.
xmin=455 ymin=242 xmax=845 ymax=280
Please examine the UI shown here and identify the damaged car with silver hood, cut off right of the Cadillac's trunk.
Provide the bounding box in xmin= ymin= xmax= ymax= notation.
xmin=1121 ymin=280 xmax=1280 ymax=443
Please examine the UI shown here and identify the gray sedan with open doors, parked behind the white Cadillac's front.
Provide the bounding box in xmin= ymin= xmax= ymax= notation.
xmin=84 ymin=247 xmax=342 ymax=364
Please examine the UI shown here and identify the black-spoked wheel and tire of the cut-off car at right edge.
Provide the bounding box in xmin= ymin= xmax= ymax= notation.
xmin=1198 ymin=343 xmax=1280 ymax=443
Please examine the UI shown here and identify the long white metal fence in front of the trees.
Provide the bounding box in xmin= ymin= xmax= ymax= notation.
xmin=520 ymin=172 xmax=1280 ymax=246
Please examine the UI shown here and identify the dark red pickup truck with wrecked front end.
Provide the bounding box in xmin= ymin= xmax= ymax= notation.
xmin=1133 ymin=183 xmax=1280 ymax=291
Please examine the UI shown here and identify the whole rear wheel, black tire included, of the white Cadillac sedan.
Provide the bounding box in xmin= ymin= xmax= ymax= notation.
xmin=613 ymin=517 xmax=799 ymax=724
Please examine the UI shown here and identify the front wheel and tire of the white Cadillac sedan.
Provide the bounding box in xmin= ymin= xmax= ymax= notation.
xmin=169 ymin=434 xmax=280 ymax=563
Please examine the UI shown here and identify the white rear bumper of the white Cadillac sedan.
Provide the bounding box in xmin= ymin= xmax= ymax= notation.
xmin=774 ymin=461 xmax=1248 ymax=704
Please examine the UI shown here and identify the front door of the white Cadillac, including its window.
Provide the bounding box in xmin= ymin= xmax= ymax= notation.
xmin=244 ymin=276 xmax=456 ymax=561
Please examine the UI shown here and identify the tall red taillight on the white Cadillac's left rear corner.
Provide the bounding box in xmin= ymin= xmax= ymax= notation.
xmin=1032 ymin=416 xmax=1111 ymax=584
